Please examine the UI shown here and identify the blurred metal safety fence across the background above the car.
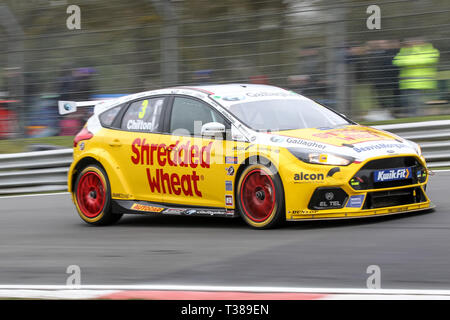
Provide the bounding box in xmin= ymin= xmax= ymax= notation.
xmin=0 ymin=0 xmax=450 ymax=138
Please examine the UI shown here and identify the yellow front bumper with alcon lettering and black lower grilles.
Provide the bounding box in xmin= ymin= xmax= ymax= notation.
xmin=280 ymin=154 xmax=434 ymax=221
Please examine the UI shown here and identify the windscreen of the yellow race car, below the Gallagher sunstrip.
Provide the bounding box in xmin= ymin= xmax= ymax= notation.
xmin=228 ymin=98 xmax=350 ymax=131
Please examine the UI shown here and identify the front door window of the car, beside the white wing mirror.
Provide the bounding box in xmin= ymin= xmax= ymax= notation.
xmin=170 ymin=97 xmax=228 ymax=135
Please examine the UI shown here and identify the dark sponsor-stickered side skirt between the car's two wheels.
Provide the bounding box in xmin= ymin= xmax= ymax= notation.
xmin=112 ymin=199 xmax=238 ymax=218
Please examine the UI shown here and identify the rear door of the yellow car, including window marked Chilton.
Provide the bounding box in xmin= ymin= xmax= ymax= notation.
xmin=106 ymin=96 xmax=167 ymax=202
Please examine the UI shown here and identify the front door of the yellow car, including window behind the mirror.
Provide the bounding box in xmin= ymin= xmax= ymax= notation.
xmin=155 ymin=96 xmax=229 ymax=208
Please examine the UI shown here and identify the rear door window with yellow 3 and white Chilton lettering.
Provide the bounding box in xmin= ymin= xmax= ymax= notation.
xmin=121 ymin=97 xmax=165 ymax=132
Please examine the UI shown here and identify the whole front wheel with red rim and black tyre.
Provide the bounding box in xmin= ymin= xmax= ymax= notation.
xmin=236 ymin=164 xmax=285 ymax=229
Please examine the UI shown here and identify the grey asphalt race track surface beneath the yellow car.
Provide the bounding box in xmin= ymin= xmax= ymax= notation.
xmin=0 ymin=172 xmax=450 ymax=289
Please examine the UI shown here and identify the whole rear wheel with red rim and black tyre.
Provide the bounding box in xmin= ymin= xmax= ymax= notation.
xmin=73 ymin=165 xmax=122 ymax=225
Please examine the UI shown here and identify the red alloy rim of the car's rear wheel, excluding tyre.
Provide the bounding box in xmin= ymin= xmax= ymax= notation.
xmin=77 ymin=171 xmax=106 ymax=218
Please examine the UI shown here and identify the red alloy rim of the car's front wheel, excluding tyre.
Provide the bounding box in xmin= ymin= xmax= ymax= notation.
xmin=241 ymin=169 xmax=276 ymax=222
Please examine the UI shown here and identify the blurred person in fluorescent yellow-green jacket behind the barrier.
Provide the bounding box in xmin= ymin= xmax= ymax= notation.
xmin=392 ymin=39 xmax=439 ymax=115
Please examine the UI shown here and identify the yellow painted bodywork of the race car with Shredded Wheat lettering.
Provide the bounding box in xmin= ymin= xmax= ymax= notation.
xmin=68 ymin=126 xmax=431 ymax=220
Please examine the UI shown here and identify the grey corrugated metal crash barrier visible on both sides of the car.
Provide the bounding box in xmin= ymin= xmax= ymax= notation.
xmin=0 ymin=120 xmax=450 ymax=195
